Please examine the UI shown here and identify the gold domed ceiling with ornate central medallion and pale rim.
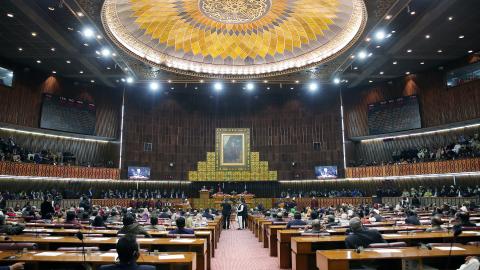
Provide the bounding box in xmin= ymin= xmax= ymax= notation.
xmin=102 ymin=0 xmax=367 ymax=78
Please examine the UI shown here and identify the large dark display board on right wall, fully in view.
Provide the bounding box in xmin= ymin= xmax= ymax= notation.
xmin=368 ymin=96 xmax=422 ymax=135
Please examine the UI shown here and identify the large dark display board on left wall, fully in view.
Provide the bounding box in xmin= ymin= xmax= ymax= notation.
xmin=40 ymin=94 xmax=96 ymax=135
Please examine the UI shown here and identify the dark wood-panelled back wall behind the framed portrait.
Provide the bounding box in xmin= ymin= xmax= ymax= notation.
xmin=124 ymin=89 xmax=343 ymax=179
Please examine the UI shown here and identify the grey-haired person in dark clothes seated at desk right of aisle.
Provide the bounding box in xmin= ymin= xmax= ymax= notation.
xmin=345 ymin=217 xmax=386 ymax=249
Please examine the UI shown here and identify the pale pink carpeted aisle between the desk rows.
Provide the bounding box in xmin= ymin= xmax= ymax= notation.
xmin=212 ymin=229 xmax=280 ymax=270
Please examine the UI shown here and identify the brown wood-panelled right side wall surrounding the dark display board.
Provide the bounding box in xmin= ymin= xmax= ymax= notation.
xmin=344 ymin=71 xmax=480 ymax=138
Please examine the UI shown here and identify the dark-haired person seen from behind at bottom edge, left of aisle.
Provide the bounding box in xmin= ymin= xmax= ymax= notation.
xmin=98 ymin=235 xmax=156 ymax=270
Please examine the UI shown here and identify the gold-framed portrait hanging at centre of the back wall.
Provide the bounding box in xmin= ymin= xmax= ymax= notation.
xmin=215 ymin=128 xmax=250 ymax=170
